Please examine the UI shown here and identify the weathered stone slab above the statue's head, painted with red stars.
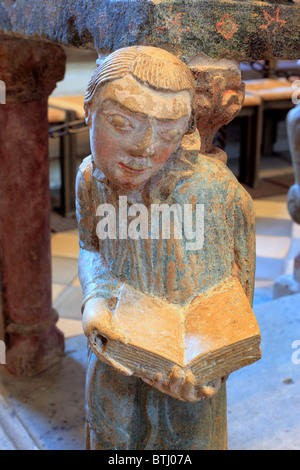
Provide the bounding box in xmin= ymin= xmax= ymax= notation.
xmin=0 ymin=0 xmax=300 ymax=60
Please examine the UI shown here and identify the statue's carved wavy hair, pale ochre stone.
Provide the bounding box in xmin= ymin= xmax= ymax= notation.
xmin=84 ymin=46 xmax=195 ymax=133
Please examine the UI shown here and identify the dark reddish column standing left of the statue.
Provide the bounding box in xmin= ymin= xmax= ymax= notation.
xmin=0 ymin=36 xmax=65 ymax=376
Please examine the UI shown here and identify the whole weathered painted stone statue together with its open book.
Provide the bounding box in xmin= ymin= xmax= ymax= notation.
xmin=76 ymin=47 xmax=260 ymax=450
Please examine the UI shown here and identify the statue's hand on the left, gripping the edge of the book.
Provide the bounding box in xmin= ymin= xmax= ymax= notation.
xmin=82 ymin=298 xmax=132 ymax=375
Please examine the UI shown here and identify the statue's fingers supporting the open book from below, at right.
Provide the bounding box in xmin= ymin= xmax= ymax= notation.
xmin=143 ymin=366 xmax=222 ymax=402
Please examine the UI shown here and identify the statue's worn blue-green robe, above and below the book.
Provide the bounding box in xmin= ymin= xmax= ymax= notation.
xmin=76 ymin=151 xmax=255 ymax=450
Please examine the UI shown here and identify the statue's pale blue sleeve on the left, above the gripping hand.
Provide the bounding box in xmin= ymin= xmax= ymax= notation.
xmin=76 ymin=165 xmax=121 ymax=313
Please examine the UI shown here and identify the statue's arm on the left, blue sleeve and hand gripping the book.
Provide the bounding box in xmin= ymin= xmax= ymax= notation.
xmin=76 ymin=170 xmax=131 ymax=375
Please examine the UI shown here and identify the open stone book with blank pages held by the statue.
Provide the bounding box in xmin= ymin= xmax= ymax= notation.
xmin=103 ymin=277 xmax=261 ymax=385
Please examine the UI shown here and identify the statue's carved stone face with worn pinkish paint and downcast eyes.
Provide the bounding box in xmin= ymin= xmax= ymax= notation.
xmin=90 ymin=75 xmax=191 ymax=189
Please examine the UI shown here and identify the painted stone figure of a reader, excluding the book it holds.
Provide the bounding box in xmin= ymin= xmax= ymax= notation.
xmin=76 ymin=46 xmax=255 ymax=450
